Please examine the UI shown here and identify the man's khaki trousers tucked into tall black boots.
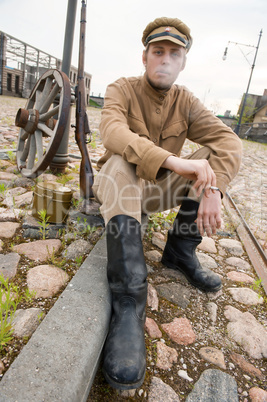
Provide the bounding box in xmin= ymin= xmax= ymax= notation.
xmin=93 ymin=147 xmax=212 ymax=224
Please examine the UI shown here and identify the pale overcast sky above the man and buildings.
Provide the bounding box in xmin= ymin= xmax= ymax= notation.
xmin=0 ymin=0 xmax=267 ymax=115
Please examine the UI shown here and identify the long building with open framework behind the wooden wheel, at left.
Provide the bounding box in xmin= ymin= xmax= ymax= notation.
xmin=0 ymin=31 xmax=92 ymax=105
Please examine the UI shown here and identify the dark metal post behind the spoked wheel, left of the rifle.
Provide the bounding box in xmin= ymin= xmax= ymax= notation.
xmin=50 ymin=0 xmax=77 ymax=173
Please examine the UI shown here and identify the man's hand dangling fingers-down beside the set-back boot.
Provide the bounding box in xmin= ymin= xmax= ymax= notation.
xmin=196 ymin=191 xmax=222 ymax=237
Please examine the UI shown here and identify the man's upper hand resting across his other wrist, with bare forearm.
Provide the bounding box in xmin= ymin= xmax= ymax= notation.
xmin=162 ymin=156 xmax=216 ymax=197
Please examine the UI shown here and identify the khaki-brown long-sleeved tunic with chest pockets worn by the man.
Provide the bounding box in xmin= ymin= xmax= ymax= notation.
xmin=98 ymin=75 xmax=242 ymax=197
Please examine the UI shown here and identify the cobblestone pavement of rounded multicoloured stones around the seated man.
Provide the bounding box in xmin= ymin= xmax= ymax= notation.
xmin=0 ymin=96 xmax=267 ymax=402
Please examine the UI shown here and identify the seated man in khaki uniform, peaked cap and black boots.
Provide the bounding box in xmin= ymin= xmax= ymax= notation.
xmin=93 ymin=18 xmax=241 ymax=389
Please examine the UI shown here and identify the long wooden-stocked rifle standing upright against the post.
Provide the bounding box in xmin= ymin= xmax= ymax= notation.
xmin=75 ymin=0 xmax=94 ymax=200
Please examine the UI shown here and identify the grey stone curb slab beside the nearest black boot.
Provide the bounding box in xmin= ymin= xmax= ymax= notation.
xmin=0 ymin=237 xmax=111 ymax=402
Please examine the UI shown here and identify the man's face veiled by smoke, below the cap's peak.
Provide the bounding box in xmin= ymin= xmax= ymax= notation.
xmin=143 ymin=40 xmax=186 ymax=91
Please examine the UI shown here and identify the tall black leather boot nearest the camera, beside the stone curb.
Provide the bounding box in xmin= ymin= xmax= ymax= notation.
xmin=103 ymin=215 xmax=147 ymax=389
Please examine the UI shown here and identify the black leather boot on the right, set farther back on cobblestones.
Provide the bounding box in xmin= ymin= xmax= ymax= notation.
xmin=162 ymin=198 xmax=222 ymax=292
